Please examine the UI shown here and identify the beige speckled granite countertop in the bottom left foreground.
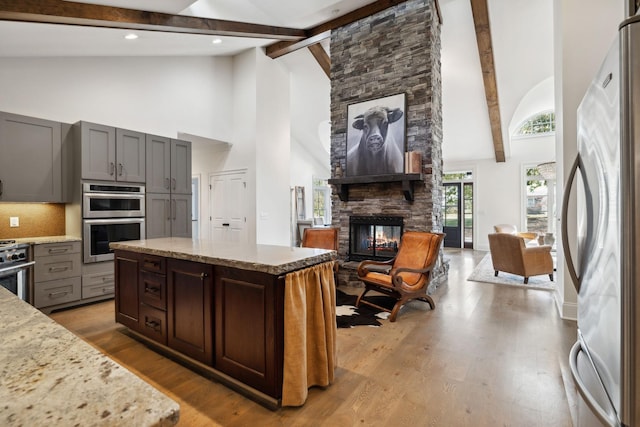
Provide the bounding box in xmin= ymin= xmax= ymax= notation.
xmin=0 ymin=286 xmax=180 ymax=426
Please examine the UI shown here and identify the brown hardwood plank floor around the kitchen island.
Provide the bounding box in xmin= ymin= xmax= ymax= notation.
xmin=51 ymin=250 xmax=576 ymax=427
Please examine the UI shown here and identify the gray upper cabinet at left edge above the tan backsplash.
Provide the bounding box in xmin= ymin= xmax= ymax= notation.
xmin=0 ymin=112 xmax=64 ymax=203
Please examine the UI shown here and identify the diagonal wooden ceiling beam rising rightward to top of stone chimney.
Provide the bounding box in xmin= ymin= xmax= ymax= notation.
xmin=266 ymin=0 xmax=407 ymax=59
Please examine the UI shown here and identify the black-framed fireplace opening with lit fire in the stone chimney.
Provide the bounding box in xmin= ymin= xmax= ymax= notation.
xmin=349 ymin=216 xmax=404 ymax=261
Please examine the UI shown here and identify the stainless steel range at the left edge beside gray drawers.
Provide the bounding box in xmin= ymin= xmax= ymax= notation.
xmin=0 ymin=240 xmax=35 ymax=303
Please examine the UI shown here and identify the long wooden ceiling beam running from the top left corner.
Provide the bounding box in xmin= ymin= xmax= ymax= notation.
xmin=0 ymin=0 xmax=307 ymax=41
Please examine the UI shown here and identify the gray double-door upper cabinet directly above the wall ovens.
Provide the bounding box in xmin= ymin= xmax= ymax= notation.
xmin=78 ymin=122 xmax=146 ymax=183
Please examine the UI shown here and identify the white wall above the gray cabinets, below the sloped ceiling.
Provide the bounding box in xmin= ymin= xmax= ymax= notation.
xmin=0 ymin=57 xmax=232 ymax=140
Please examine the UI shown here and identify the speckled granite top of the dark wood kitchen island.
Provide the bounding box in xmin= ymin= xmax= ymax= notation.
xmin=110 ymin=237 xmax=336 ymax=275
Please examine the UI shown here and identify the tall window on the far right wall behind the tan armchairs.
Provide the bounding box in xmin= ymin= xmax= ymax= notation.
xmin=525 ymin=166 xmax=552 ymax=233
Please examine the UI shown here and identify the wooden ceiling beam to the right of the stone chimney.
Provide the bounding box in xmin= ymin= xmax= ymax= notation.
xmin=471 ymin=0 xmax=506 ymax=162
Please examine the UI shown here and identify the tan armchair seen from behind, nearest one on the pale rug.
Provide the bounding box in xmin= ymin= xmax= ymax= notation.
xmin=489 ymin=233 xmax=553 ymax=284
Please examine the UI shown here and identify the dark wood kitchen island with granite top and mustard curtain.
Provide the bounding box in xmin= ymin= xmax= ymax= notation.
xmin=110 ymin=237 xmax=336 ymax=409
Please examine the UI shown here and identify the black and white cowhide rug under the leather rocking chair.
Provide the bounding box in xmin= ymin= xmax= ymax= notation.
xmin=336 ymin=289 xmax=395 ymax=328
